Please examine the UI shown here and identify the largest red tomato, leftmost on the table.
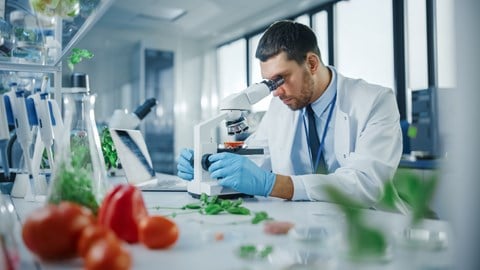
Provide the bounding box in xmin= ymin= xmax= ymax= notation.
xmin=22 ymin=202 xmax=94 ymax=260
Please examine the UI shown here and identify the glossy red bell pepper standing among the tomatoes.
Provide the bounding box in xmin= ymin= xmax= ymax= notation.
xmin=98 ymin=184 xmax=148 ymax=243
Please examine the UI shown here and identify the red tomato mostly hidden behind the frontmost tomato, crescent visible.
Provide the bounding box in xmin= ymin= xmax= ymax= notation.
xmin=77 ymin=225 xmax=120 ymax=257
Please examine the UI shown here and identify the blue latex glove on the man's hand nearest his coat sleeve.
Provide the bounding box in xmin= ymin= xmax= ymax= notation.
xmin=208 ymin=152 xmax=276 ymax=197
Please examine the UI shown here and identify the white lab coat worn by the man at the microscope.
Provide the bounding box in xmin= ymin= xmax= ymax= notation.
xmin=246 ymin=73 xmax=403 ymax=209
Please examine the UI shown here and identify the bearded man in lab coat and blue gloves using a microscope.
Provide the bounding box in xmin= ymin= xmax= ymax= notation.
xmin=177 ymin=21 xmax=402 ymax=209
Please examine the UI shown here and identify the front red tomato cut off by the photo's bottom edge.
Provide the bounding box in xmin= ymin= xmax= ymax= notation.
xmin=85 ymin=239 xmax=132 ymax=270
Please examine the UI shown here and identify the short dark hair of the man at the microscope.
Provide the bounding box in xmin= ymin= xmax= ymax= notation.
xmin=255 ymin=20 xmax=321 ymax=64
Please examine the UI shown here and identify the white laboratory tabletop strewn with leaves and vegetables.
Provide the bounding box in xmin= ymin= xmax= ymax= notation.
xmin=6 ymin=192 xmax=453 ymax=269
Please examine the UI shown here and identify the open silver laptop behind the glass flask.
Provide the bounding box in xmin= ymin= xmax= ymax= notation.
xmin=110 ymin=128 xmax=187 ymax=191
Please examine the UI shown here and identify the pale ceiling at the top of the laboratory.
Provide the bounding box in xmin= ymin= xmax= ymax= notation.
xmin=98 ymin=0 xmax=329 ymax=43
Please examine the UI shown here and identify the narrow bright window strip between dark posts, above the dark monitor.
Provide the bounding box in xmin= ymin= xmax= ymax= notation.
xmin=406 ymin=0 xmax=428 ymax=89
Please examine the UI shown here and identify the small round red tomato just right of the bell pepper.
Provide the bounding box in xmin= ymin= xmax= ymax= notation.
xmin=138 ymin=216 xmax=179 ymax=249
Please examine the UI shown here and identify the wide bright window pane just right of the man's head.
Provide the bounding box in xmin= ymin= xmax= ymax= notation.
xmin=336 ymin=0 xmax=394 ymax=88
